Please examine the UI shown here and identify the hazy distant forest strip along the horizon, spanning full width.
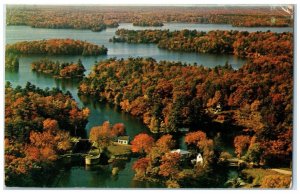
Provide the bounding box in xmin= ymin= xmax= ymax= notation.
xmin=6 ymin=6 xmax=293 ymax=27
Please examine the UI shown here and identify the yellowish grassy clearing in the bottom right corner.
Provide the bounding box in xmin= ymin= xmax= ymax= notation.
xmin=242 ymin=168 xmax=290 ymax=188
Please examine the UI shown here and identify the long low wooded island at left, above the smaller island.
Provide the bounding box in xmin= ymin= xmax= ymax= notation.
xmin=5 ymin=39 xmax=107 ymax=56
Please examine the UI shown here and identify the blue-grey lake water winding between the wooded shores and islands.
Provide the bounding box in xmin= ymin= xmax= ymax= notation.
xmin=5 ymin=23 xmax=292 ymax=188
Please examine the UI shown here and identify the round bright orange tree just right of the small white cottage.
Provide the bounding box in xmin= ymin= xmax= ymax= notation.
xmin=131 ymin=133 xmax=154 ymax=154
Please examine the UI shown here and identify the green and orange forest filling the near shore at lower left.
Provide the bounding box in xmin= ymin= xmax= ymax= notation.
xmin=5 ymin=82 xmax=89 ymax=187
